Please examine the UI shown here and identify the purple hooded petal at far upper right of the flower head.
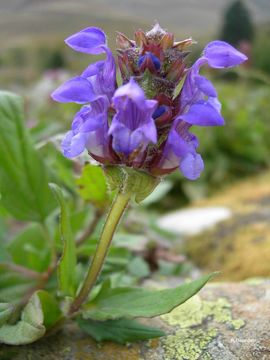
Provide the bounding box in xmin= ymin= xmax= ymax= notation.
xmin=203 ymin=40 xmax=247 ymax=69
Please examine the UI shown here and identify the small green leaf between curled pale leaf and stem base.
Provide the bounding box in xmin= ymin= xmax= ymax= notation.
xmin=37 ymin=290 xmax=62 ymax=329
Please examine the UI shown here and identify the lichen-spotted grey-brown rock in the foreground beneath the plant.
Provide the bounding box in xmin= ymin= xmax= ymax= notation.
xmin=0 ymin=281 xmax=270 ymax=360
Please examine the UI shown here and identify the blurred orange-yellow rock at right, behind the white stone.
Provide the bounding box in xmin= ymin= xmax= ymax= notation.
xmin=184 ymin=172 xmax=270 ymax=281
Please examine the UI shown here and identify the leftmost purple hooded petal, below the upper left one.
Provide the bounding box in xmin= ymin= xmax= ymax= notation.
xmin=51 ymin=76 xmax=97 ymax=104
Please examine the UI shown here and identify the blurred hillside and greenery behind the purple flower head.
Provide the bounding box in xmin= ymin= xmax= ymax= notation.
xmin=0 ymin=0 xmax=270 ymax=208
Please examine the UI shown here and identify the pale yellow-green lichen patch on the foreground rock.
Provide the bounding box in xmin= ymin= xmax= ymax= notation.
xmin=161 ymin=295 xmax=245 ymax=360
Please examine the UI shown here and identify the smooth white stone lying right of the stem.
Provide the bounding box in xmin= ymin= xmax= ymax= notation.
xmin=158 ymin=207 xmax=232 ymax=236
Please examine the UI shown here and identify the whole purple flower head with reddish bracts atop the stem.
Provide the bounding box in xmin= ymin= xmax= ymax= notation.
xmin=52 ymin=24 xmax=247 ymax=180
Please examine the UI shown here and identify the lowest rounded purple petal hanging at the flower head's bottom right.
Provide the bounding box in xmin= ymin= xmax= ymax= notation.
xmin=179 ymin=153 xmax=204 ymax=180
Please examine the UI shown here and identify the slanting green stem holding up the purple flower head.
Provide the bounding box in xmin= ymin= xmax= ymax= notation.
xmin=69 ymin=192 xmax=130 ymax=314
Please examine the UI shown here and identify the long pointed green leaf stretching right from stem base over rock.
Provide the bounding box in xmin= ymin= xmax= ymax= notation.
xmin=83 ymin=273 xmax=216 ymax=320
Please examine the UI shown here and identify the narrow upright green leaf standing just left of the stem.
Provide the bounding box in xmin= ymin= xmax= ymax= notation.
xmin=50 ymin=183 xmax=76 ymax=296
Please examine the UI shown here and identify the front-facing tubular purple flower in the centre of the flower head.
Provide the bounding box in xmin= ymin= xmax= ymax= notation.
xmin=109 ymin=78 xmax=157 ymax=157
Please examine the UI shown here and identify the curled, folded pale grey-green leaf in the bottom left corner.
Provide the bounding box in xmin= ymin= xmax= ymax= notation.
xmin=0 ymin=294 xmax=46 ymax=345
